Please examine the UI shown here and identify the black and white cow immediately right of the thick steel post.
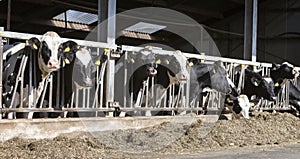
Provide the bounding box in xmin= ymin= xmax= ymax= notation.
xmin=114 ymin=49 xmax=157 ymax=106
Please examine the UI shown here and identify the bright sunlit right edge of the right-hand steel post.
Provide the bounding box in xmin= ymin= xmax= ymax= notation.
xmin=252 ymin=0 xmax=258 ymax=62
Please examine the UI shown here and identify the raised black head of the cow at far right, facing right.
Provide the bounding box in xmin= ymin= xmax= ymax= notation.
xmin=271 ymin=62 xmax=298 ymax=82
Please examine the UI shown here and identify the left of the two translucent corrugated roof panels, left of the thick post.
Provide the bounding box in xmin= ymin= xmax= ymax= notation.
xmin=53 ymin=9 xmax=98 ymax=25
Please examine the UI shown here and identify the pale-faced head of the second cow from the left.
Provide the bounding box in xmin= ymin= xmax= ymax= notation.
xmin=73 ymin=48 xmax=96 ymax=88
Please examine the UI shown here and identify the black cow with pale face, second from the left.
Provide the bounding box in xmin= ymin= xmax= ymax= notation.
xmin=36 ymin=41 xmax=96 ymax=117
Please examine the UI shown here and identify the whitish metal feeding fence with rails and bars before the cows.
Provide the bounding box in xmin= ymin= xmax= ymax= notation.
xmin=0 ymin=28 xmax=296 ymax=119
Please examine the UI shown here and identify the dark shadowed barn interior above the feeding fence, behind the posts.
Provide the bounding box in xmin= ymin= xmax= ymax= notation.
xmin=0 ymin=0 xmax=300 ymax=65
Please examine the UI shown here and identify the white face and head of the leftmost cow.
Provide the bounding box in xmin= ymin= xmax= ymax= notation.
xmin=38 ymin=31 xmax=61 ymax=73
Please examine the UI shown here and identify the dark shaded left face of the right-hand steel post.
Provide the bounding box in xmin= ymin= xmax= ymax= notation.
xmin=244 ymin=0 xmax=253 ymax=60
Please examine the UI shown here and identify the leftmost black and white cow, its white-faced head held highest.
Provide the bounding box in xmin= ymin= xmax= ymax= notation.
xmin=2 ymin=32 xmax=61 ymax=117
